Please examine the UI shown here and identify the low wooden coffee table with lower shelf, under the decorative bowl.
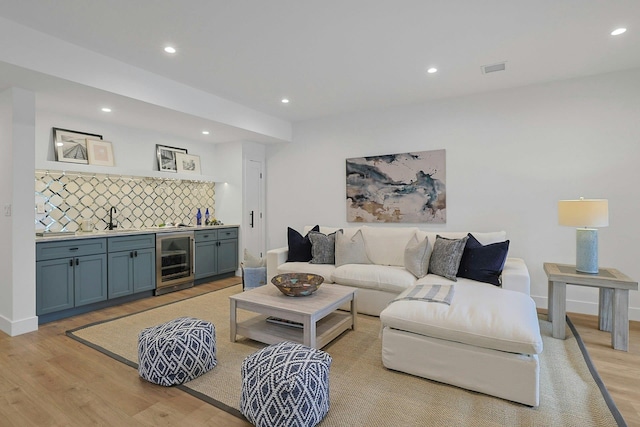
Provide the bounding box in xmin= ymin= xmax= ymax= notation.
xmin=229 ymin=283 xmax=356 ymax=348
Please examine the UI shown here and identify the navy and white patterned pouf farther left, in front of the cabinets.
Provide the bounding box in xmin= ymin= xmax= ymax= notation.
xmin=138 ymin=317 xmax=218 ymax=387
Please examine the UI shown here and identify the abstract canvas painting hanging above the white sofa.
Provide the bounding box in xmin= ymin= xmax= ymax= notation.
xmin=347 ymin=150 xmax=447 ymax=224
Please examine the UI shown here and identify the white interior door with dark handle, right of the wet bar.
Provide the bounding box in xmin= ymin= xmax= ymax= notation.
xmin=243 ymin=159 xmax=266 ymax=257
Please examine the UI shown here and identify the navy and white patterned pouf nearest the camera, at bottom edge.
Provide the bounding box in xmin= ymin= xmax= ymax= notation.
xmin=240 ymin=341 xmax=331 ymax=427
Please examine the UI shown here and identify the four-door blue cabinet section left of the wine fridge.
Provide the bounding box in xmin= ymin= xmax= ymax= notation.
xmin=36 ymin=233 xmax=156 ymax=324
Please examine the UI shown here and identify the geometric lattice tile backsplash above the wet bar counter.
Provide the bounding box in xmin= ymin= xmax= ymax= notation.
xmin=34 ymin=170 xmax=216 ymax=231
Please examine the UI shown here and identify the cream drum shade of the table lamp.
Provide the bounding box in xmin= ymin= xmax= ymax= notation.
xmin=558 ymin=198 xmax=609 ymax=228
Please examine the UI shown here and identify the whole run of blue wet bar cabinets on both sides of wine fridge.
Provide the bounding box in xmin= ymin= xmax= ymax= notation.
xmin=36 ymin=226 xmax=238 ymax=323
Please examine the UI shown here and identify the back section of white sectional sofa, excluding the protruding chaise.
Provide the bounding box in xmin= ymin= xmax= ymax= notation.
xmin=267 ymin=225 xmax=530 ymax=316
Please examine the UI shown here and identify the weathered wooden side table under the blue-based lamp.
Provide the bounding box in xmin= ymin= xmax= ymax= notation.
xmin=544 ymin=262 xmax=638 ymax=351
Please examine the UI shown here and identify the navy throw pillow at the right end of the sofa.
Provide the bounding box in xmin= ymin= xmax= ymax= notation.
xmin=458 ymin=233 xmax=509 ymax=286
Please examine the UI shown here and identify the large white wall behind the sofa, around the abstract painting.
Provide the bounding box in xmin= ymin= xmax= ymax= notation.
xmin=267 ymin=69 xmax=640 ymax=320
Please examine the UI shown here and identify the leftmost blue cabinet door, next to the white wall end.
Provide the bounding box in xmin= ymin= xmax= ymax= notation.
xmin=36 ymin=258 xmax=75 ymax=315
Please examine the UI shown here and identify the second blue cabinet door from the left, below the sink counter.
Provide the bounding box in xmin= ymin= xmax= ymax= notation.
xmin=74 ymin=254 xmax=107 ymax=307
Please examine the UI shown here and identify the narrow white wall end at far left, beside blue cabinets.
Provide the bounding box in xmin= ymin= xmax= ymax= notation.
xmin=0 ymin=88 xmax=38 ymax=336
